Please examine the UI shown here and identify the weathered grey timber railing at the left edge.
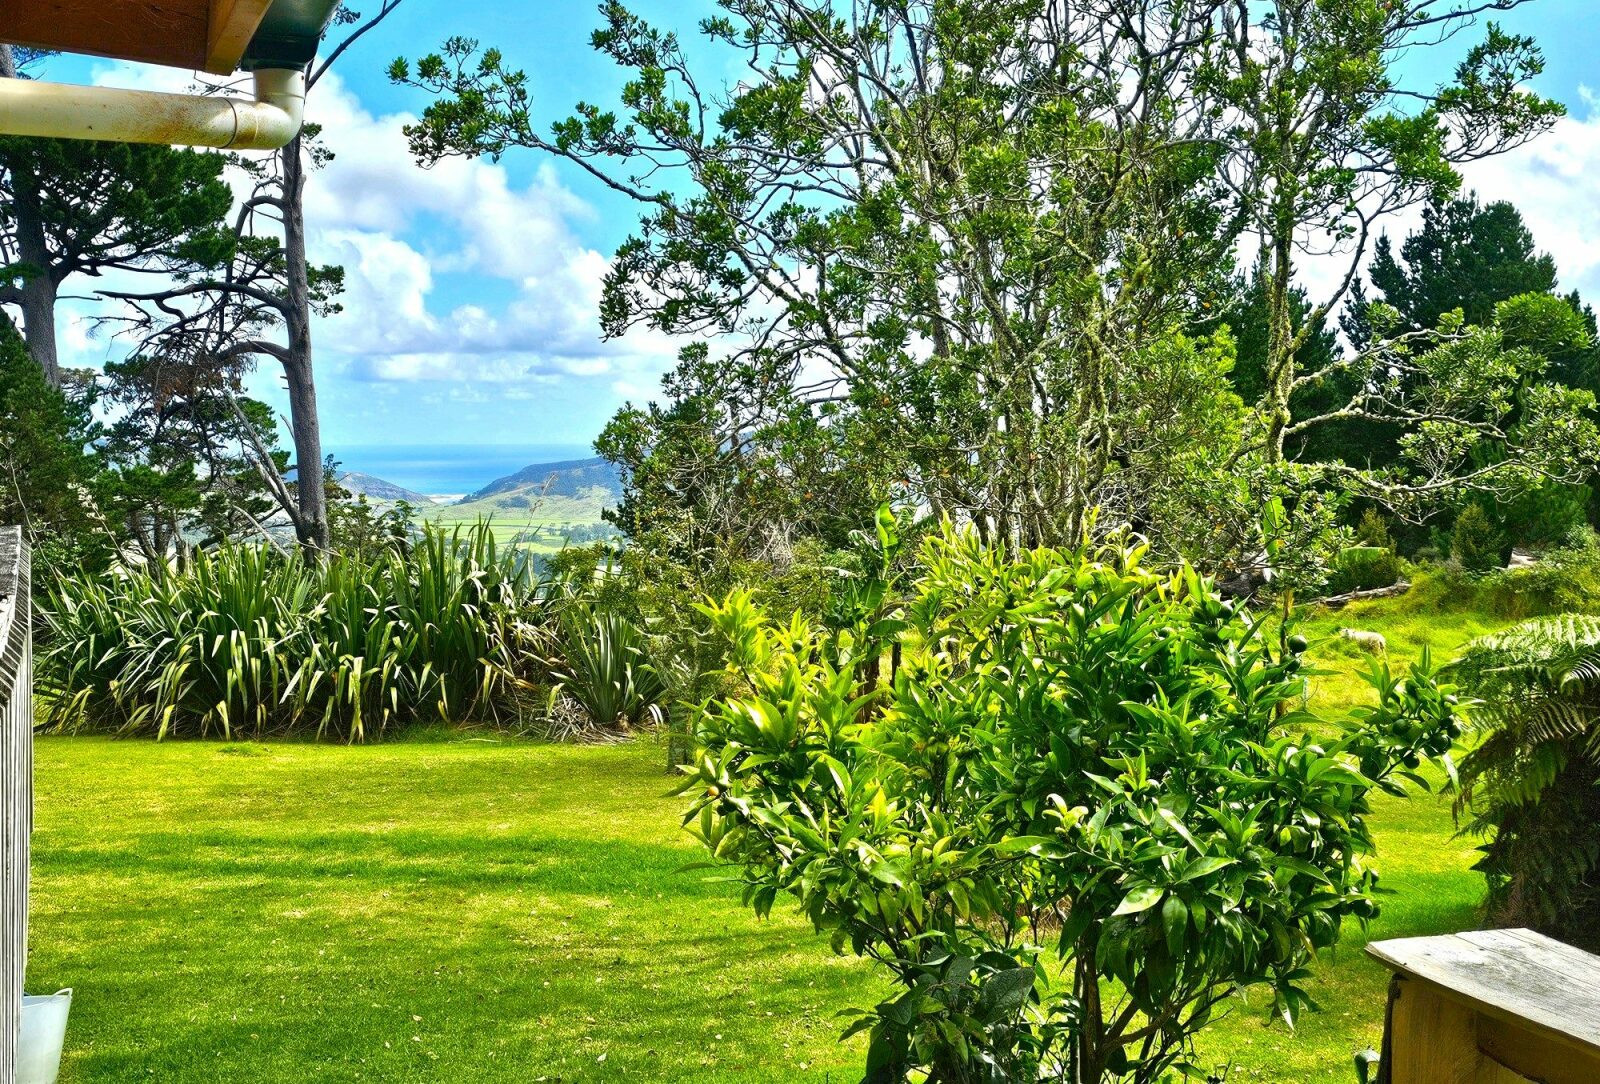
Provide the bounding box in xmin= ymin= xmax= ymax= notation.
xmin=0 ymin=528 xmax=34 ymax=1084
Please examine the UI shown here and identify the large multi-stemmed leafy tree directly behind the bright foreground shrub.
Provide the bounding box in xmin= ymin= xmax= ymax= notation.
xmin=392 ymin=10 xmax=1240 ymax=564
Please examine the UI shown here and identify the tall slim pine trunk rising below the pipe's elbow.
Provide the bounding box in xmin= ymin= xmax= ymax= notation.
xmin=278 ymin=136 xmax=328 ymax=553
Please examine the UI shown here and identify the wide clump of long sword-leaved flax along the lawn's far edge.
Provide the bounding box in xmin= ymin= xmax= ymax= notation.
xmin=38 ymin=526 xmax=546 ymax=742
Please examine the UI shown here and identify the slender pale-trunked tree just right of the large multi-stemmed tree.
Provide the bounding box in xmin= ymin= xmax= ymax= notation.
xmin=1203 ymin=0 xmax=1563 ymax=489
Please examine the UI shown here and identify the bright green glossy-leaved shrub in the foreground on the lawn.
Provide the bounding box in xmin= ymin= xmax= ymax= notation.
xmin=686 ymin=528 xmax=1458 ymax=1084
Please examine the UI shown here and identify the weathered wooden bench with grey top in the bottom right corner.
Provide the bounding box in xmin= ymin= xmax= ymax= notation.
xmin=1366 ymin=929 xmax=1600 ymax=1084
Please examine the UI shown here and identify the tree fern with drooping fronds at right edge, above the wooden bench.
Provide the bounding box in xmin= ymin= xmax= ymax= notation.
xmin=1451 ymin=614 xmax=1600 ymax=948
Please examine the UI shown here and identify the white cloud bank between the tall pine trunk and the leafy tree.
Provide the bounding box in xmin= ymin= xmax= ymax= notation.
xmin=78 ymin=64 xmax=675 ymax=389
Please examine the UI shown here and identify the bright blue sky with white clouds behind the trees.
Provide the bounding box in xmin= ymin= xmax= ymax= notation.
xmin=37 ymin=0 xmax=1600 ymax=446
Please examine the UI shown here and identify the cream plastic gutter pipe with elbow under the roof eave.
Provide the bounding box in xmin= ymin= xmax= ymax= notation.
xmin=0 ymin=67 xmax=306 ymax=150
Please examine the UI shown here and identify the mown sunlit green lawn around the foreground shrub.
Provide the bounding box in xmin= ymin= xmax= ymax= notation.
xmin=29 ymin=722 xmax=1478 ymax=1084
